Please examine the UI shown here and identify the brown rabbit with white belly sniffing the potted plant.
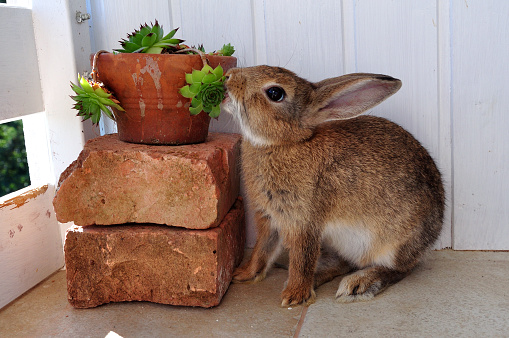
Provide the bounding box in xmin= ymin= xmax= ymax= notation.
xmin=223 ymin=66 xmax=444 ymax=306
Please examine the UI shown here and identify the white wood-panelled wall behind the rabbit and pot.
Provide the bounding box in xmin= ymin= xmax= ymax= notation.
xmin=88 ymin=0 xmax=509 ymax=250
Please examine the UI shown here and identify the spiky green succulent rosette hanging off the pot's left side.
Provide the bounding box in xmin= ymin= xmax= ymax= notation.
xmin=71 ymin=75 xmax=124 ymax=124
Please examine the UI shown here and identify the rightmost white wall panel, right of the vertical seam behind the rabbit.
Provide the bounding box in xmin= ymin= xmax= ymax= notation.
xmin=451 ymin=0 xmax=509 ymax=250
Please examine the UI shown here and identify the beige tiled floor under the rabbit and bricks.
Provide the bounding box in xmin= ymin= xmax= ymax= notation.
xmin=0 ymin=251 xmax=509 ymax=337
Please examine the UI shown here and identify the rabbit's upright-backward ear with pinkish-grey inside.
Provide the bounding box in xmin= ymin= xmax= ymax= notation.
xmin=303 ymin=74 xmax=401 ymax=125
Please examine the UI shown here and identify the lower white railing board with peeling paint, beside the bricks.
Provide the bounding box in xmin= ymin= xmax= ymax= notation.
xmin=0 ymin=186 xmax=64 ymax=308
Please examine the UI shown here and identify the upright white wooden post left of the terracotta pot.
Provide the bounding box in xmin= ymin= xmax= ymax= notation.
xmin=32 ymin=0 xmax=84 ymax=184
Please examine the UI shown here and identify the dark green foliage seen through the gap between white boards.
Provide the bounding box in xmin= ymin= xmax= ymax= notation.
xmin=0 ymin=120 xmax=30 ymax=196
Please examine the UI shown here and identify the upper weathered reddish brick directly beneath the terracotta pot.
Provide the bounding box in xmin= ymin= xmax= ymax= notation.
xmin=53 ymin=133 xmax=240 ymax=229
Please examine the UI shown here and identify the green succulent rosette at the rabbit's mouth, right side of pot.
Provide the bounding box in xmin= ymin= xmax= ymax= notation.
xmin=179 ymin=65 xmax=225 ymax=118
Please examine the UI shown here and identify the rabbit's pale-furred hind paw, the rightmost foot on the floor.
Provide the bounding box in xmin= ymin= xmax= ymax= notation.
xmin=336 ymin=270 xmax=382 ymax=303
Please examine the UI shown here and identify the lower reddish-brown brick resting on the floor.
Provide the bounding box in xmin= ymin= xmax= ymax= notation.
xmin=65 ymin=199 xmax=245 ymax=308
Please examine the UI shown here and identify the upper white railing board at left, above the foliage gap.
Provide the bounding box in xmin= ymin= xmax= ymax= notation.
xmin=0 ymin=5 xmax=44 ymax=121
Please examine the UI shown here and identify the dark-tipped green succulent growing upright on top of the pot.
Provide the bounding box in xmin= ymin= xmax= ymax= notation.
xmin=114 ymin=20 xmax=184 ymax=54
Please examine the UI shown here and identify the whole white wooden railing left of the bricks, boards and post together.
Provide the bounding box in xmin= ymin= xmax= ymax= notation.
xmin=0 ymin=0 xmax=90 ymax=308
